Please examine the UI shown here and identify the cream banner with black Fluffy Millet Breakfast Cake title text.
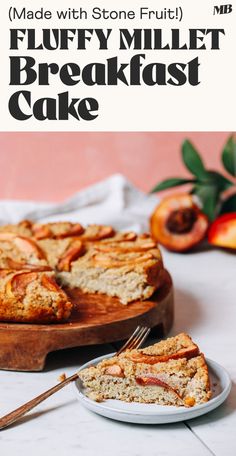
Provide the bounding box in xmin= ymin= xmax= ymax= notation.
xmin=0 ymin=0 xmax=236 ymax=131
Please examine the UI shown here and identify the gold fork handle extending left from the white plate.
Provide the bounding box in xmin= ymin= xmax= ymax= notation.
xmin=0 ymin=374 xmax=79 ymax=430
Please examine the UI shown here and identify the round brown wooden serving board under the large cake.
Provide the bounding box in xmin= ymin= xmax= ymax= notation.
xmin=0 ymin=271 xmax=174 ymax=371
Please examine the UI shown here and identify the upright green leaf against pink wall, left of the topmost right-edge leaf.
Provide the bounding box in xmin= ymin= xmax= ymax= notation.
xmin=182 ymin=140 xmax=208 ymax=180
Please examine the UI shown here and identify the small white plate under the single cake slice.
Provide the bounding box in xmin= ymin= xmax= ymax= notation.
xmin=75 ymin=354 xmax=231 ymax=424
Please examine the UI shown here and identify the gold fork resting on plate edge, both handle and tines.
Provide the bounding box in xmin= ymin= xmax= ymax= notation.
xmin=0 ymin=326 xmax=151 ymax=430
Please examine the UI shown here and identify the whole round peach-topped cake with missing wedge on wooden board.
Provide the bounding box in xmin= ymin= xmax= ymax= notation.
xmin=0 ymin=220 xmax=164 ymax=323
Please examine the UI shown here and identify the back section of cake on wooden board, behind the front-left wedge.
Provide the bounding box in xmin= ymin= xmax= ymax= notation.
xmin=0 ymin=220 xmax=164 ymax=304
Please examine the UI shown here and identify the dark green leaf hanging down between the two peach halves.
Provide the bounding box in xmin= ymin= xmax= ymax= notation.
xmin=193 ymin=184 xmax=219 ymax=221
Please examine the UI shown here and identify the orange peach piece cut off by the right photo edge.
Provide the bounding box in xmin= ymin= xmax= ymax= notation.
xmin=208 ymin=212 xmax=236 ymax=249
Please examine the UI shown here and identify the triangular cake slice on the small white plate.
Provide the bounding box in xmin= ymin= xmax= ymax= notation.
xmin=79 ymin=334 xmax=211 ymax=407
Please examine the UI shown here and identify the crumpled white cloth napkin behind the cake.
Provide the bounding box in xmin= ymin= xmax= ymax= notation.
xmin=0 ymin=174 xmax=157 ymax=232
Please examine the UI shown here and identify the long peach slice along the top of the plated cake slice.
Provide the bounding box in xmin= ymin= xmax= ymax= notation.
xmin=126 ymin=347 xmax=199 ymax=364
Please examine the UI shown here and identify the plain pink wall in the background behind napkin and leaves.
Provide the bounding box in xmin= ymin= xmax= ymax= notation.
xmin=0 ymin=132 xmax=229 ymax=201
